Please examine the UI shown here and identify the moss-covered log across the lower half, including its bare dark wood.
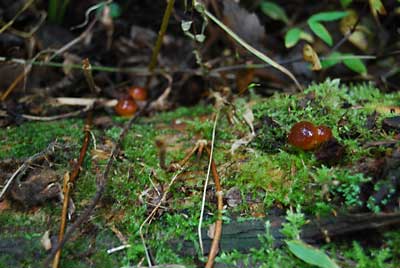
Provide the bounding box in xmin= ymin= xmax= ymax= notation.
xmin=0 ymin=80 xmax=400 ymax=267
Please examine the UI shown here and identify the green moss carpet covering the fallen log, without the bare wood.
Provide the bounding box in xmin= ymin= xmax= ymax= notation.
xmin=0 ymin=80 xmax=400 ymax=267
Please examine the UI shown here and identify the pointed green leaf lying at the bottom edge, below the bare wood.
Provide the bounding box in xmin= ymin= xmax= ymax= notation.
xmin=286 ymin=240 xmax=339 ymax=268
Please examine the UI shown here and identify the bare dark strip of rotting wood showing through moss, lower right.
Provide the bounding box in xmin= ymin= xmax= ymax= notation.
xmin=171 ymin=213 xmax=400 ymax=256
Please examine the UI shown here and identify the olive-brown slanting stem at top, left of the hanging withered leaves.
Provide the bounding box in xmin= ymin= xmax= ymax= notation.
xmin=145 ymin=0 xmax=175 ymax=88
